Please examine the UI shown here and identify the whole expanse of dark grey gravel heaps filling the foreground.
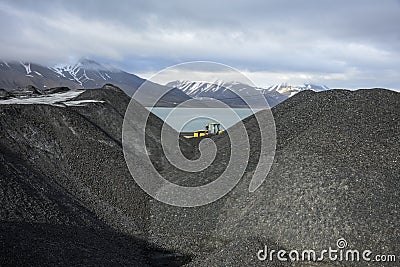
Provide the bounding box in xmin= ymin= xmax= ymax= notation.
xmin=0 ymin=85 xmax=400 ymax=266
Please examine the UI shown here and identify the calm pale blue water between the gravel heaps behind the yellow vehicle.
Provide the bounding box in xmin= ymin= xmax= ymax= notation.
xmin=148 ymin=107 xmax=258 ymax=132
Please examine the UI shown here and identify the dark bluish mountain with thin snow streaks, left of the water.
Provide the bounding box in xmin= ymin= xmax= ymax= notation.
xmin=0 ymin=59 xmax=190 ymax=106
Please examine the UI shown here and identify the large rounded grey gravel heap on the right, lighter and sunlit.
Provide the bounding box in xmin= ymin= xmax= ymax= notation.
xmin=145 ymin=89 xmax=400 ymax=266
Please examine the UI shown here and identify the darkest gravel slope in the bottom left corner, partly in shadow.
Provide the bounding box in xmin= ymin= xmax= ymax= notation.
xmin=0 ymin=133 xmax=151 ymax=266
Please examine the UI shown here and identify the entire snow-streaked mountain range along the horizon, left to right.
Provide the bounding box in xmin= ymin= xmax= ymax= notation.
xmin=0 ymin=58 xmax=329 ymax=107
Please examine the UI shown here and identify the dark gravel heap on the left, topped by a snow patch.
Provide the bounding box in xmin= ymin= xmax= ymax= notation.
xmin=0 ymin=86 xmax=187 ymax=266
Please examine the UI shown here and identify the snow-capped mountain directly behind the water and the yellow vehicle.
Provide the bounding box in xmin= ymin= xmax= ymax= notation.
xmin=166 ymin=81 xmax=287 ymax=107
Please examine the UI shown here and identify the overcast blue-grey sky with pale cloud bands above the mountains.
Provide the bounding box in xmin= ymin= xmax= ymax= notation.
xmin=0 ymin=0 xmax=400 ymax=89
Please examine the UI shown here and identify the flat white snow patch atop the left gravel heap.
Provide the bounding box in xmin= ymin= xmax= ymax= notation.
xmin=0 ymin=90 xmax=104 ymax=106
